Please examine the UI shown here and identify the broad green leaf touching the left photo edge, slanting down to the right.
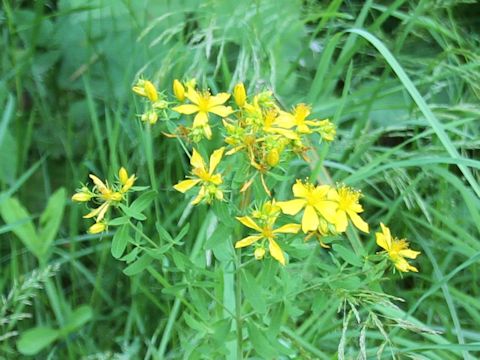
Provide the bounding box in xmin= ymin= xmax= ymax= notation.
xmin=0 ymin=198 xmax=42 ymax=259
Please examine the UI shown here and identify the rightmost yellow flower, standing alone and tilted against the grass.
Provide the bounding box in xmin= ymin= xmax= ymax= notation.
xmin=375 ymin=223 xmax=420 ymax=272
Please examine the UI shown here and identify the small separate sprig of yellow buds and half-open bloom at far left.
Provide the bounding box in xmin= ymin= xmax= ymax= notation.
xmin=72 ymin=167 xmax=136 ymax=234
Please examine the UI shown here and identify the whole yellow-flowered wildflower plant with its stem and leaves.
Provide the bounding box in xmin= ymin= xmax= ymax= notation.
xmin=72 ymin=79 xmax=420 ymax=358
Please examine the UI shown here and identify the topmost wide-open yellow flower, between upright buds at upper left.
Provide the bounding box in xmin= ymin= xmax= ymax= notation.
xmin=173 ymin=87 xmax=233 ymax=139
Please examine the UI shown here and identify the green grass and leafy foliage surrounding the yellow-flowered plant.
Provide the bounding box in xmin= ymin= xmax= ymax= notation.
xmin=0 ymin=0 xmax=480 ymax=359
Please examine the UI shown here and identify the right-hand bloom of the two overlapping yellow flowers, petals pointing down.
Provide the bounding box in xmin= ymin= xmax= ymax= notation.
xmin=331 ymin=186 xmax=369 ymax=233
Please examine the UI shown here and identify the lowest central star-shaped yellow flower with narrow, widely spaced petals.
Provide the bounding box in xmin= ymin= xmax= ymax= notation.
xmin=235 ymin=210 xmax=300 ymax=265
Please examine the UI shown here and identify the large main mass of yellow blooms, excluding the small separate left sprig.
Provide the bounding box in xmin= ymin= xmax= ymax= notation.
xmin=129 ymin=76 xmax=419 ymax=272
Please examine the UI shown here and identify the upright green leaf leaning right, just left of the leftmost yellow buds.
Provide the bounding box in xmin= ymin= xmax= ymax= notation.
xmin=38 ymin=188 xmax=67 ymax=254
